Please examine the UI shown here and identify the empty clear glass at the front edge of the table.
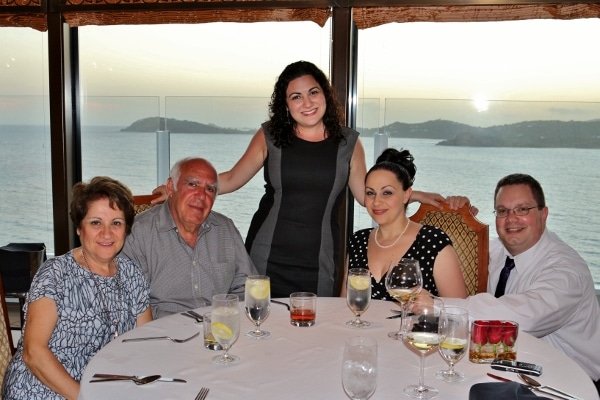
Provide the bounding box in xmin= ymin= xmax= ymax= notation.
xmin=342 ymin=336 xmax=377 ymax=400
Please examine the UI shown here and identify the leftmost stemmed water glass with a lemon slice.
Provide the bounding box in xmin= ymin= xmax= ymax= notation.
xmin=211 ymin=294 xmax=240 ymax=365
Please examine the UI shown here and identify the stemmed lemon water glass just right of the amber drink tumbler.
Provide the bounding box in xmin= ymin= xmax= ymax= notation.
xmin=346 ymin=268 xmax=371 ymax=328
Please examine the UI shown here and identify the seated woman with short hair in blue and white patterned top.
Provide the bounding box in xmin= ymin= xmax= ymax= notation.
xmin=2 ymin=177 xmax=152 ymax=400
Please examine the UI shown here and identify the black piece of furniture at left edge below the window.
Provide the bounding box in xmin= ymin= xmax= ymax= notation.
xmin=0 ymin=243 xmax=47 ymax=326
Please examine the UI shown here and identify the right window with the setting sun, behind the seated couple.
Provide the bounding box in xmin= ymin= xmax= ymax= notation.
xmin=355 ymin=19 xmax=600 ymax=282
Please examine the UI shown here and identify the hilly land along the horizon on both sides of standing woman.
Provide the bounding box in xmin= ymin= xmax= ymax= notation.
xmin=121 ymin=117 xmax=600 ymax=149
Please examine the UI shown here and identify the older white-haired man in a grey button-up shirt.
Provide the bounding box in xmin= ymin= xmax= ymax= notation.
xmin=123 ymin=158 xmax=256 ymax=318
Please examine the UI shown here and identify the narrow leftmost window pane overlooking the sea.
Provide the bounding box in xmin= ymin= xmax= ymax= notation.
xmin=0 ymin=28 xmax=54 ymax=254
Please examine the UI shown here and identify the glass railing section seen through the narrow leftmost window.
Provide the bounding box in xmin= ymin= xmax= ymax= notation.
xmin=0 ymin=95 xmax=54 ymax=253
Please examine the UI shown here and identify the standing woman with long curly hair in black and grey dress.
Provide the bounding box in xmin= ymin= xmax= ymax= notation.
xmin=219 ymin=61 xmax=443 ymax=297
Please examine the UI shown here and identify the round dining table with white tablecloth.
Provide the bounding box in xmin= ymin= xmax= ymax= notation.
xmin=79 ymin=297 xmax=598 ymax=400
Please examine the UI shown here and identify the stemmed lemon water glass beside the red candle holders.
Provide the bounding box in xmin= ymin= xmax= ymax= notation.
xmin=435 ymin=307 xmax=469 ymax=382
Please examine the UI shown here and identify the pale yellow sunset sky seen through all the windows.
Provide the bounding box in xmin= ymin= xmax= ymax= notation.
xmin=0 ymin=19 xmax=600 ymax=128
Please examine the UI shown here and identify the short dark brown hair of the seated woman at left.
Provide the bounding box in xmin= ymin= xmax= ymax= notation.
xmin=69 ymin=176 xmax=135 ymax=235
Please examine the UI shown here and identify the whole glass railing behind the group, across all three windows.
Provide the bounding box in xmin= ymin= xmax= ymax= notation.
xmin=0 ymin=96 xmax=600 ymax=289
